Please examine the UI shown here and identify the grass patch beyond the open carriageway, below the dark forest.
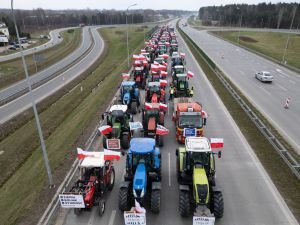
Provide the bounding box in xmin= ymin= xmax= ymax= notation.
xmin=213 ymin=31 xmax=300 ymax=69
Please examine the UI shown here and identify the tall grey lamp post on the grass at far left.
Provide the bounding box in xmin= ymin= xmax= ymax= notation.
xmin=11 ymin=0 xmax=54 ymax=187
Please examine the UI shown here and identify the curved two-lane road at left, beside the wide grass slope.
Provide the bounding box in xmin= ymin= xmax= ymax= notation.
xmin=0 ymin=27 xmax=104 ymax=124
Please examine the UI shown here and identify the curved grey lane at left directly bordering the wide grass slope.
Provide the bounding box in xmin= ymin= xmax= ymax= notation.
xmin=0 ymin=29 xmax=104 ymax=124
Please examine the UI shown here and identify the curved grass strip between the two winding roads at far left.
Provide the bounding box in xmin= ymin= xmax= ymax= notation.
xmin=0 ymin=28 xmax=81 ymax=89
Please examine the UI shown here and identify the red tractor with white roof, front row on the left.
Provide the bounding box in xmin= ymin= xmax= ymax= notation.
xmin=60 ymin=155 xmax=115 ymax=216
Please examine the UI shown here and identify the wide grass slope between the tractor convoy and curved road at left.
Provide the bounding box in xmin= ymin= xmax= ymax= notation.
xmin=0 ymin=25 xmax=149 ymax=225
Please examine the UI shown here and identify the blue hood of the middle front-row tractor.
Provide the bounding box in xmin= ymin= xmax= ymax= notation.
xmin=133 ymin=163 xmax=147 ymax=198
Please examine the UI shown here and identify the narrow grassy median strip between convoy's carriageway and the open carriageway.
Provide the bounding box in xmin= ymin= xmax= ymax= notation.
xmin=177 ymin=23 xmax=300 ymax=220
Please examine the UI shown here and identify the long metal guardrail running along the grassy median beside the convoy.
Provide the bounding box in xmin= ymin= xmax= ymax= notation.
xmin=178 ymin=26 xmax=300 ymax=179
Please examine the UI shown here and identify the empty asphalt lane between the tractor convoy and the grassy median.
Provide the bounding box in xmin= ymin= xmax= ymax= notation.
xmin=179 ymin=30 xmax=297 ymax=225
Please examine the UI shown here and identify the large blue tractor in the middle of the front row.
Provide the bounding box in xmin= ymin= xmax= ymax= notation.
xmin=119 ymin=138 xmax=161 ymax=213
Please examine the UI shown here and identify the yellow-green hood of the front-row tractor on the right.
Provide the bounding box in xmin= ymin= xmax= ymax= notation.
xmin=193 ymin=166 xmax=209 ymax=205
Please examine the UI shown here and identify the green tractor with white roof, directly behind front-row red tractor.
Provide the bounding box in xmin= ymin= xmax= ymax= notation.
xmin=102 ymin=105 xmax=133 ymax=149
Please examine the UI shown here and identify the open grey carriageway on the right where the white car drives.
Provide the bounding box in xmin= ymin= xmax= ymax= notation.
xmin=180 ymin=20 xmax=300 ymax=154
